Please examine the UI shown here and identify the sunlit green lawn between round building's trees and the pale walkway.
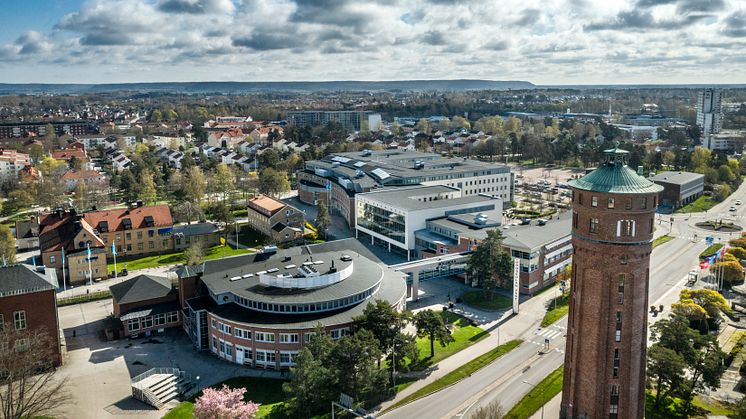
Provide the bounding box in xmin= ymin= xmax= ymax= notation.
xmin=410 ymin=311 xmax=488 ymax=370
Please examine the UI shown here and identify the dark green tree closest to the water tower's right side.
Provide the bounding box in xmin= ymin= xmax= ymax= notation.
xmin=647 ymin=343 xmax=686 ymax=409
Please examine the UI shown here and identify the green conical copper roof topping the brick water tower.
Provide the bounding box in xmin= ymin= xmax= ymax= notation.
xmin=569 ymin=148 xmax=663 ymax=194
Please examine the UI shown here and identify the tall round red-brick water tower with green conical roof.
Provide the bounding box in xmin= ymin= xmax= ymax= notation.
xmin=560 ymin=148 xmax=663 ymax=419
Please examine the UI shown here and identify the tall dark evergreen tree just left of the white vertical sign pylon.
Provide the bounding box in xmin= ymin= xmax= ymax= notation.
xmin=466 ymin=230 xmax=512 ymax=300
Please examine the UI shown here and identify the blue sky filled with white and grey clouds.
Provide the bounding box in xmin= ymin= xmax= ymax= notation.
xmin=0 ymin=0 xmax=746 ymax=84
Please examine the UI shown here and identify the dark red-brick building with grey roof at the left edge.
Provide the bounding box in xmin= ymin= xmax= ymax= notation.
xmin=0 ymin=265 xmax=62 ymax=366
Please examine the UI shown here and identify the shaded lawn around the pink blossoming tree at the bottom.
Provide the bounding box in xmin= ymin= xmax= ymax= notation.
xmin=163 ymin=377 xmax=286 ymax=419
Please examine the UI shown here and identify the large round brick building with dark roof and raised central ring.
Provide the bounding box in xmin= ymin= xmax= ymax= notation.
xmin=177 ymin=239 xmax=406 ymax=370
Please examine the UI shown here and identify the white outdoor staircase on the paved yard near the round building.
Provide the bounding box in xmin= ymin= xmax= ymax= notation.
xmin=132 ymin=368 xmax=193 ymax=409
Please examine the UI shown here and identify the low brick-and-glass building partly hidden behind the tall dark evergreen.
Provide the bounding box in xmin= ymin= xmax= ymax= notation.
xmin=415 ymin=213 xmax=572 ymax=294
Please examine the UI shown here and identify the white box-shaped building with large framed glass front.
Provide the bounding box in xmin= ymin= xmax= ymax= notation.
xmin=355 ymin=186 xmax=503 ymax=259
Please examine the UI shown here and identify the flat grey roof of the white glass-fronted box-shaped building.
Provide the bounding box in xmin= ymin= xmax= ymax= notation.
xmin=357 ymin=185 xmax=502 ymax=211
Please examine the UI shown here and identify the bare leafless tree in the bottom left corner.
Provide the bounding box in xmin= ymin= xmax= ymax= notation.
xmin=0 ymin=324 xmax=68 ymax=419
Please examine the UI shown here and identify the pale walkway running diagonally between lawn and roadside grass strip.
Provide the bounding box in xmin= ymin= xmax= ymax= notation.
xmin=371 ymin=291 xmax=553 ymax=413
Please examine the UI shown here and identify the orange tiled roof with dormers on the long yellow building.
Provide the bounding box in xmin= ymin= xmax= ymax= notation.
xmin=83 ymin=205 xmax=174 ymax=231
